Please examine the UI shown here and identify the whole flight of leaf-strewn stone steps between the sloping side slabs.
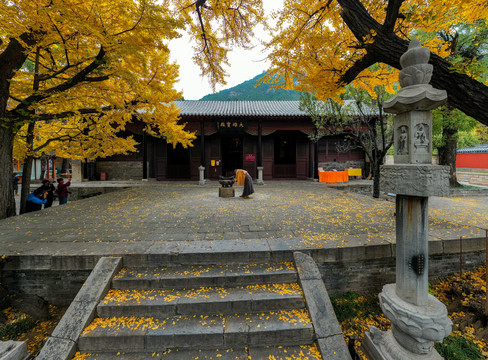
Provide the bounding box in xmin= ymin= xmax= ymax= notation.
xmin=75 ymin=260 xmax=341 ymax=360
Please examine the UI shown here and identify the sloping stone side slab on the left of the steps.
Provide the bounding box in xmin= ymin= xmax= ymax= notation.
xmin=36 ymin=257 xmax=122 ymax=360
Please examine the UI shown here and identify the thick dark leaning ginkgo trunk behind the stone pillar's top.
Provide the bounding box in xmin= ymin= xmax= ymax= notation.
xmin=337 ymin=0 xmax=488 ymax=125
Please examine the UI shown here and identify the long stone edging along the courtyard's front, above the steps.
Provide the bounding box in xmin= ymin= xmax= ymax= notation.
xmin=2 ymin=237 xmax=486 ymax=271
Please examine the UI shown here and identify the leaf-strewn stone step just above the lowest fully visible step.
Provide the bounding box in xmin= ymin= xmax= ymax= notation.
xmin=97 ymin=283 xmax=305 ymax=317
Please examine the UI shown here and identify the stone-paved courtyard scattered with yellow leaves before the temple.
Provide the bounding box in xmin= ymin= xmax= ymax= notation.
xmin=0 ymin=181 xmax=488 ymax=255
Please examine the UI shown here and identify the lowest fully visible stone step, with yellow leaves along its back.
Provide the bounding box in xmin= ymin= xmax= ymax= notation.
xmin=78 ymin=309 xmax=314 ymax=353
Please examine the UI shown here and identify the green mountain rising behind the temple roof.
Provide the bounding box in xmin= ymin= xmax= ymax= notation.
xmin=200 ymin=73 xmax=300 ymax=101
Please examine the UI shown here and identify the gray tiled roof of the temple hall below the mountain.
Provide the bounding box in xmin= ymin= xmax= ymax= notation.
xmin=175 ymin=100 xmax=307 ymax=117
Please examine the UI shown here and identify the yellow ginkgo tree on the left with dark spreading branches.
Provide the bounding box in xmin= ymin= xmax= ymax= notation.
xmin=0 ymin=0 xmax=263 ymax=218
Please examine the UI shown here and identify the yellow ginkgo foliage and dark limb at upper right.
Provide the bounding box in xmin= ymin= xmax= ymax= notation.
xmin=267 ymin=0 xmax=488 ymax=121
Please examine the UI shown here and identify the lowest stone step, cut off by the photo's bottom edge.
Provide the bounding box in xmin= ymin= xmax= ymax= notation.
xmin=73 ymin=345 xmax=322 ymax=360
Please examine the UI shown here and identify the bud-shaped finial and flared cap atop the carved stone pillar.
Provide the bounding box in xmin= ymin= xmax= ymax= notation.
xmin=383 ymin=39 xmax=447 ymax=114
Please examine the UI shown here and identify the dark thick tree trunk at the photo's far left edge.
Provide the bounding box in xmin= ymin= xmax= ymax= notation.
xmin=0 ymin=129 xmax=16 ymax=219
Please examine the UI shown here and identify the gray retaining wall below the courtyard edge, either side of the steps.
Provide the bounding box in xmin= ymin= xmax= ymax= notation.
xmin=1 ymin=238 xmax=485 ymax=305
